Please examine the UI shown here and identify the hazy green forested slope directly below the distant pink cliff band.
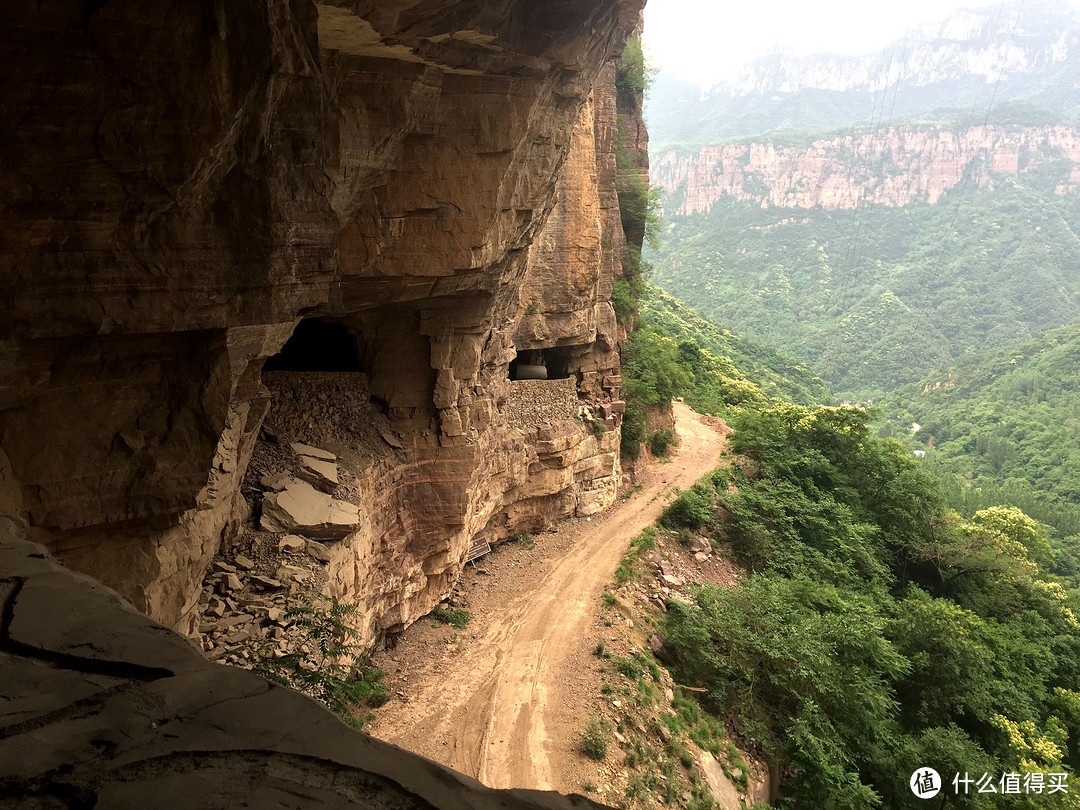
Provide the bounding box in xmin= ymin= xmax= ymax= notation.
xmin=651 ymin=177 xmax=1080 ymax=396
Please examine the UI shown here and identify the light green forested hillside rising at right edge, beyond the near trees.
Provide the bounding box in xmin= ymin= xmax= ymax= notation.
xmin=883 ymin=325 xmax=1080 ymax=546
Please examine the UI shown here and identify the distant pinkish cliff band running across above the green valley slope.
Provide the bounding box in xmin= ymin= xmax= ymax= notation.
xmin=651 ymin=125 xmax=1080 ymax=214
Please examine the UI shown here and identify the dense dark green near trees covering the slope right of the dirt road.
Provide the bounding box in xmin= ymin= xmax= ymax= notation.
xmin=662 ymin=403 xmax=1080 ymax=810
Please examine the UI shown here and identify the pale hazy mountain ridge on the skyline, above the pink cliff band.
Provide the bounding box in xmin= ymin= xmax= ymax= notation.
xmin=645 ymin=0 xmax=1080 ymax=147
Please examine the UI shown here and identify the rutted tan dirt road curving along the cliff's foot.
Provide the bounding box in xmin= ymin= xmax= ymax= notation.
xmin=368 ymin=403 xmax=724 ymax=791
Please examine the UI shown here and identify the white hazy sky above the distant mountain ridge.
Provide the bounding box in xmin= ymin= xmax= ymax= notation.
xmin=645 ymin=0 xmax=1080 ymax=86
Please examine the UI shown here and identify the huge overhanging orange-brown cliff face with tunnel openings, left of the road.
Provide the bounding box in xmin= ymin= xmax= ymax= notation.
xmin=0 ymin=0 xmax=642 ymax=637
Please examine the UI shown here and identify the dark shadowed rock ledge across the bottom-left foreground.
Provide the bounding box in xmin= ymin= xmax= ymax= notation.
xmin=0 ymin=516 xmax=599 ymax=810
